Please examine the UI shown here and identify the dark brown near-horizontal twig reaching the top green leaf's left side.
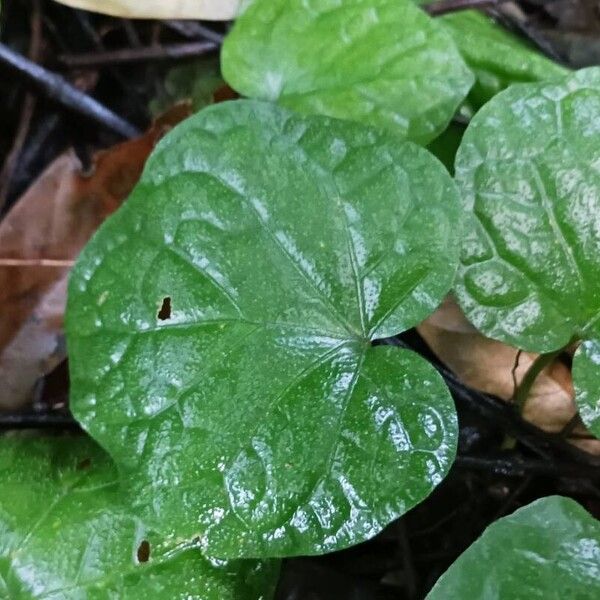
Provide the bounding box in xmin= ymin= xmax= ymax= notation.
xmin=58 ymin=42 xmax=218 ymax=69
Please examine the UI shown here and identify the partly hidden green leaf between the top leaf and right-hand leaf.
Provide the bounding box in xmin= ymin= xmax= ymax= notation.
xmin=420 ymin=7 xmax=569 ymax=109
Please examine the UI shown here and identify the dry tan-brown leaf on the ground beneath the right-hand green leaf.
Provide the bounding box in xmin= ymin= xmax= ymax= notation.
xmin=417 ymin=298 xmax=600 ymax=455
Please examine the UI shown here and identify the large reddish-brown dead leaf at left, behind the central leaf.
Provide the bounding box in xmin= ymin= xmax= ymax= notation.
xmin=0 ymin=104 xmax=190 ymax=409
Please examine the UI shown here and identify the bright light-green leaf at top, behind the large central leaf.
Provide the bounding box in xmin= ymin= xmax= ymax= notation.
xmin=221 ymin=0 xmax=473 ymax=144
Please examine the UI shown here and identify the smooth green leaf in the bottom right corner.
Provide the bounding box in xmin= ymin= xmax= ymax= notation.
xmin=427 ymin=496 xmax=600 ymax=600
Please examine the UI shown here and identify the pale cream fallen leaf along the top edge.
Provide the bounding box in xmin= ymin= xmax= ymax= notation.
xmin=51 ymin=0 xmax=240 ymax=21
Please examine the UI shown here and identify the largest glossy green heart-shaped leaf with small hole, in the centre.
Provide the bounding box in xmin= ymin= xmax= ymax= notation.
xmin=67 ymin=101 xmax=460 ymax=558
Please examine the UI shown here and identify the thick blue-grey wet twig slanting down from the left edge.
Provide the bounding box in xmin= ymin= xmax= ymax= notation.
xmin=0 ymin=44 xmax=140 ymax=138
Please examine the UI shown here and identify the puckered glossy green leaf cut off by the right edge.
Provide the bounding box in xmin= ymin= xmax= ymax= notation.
xmin=456 ymin=68 xmax=600 ymax=432
